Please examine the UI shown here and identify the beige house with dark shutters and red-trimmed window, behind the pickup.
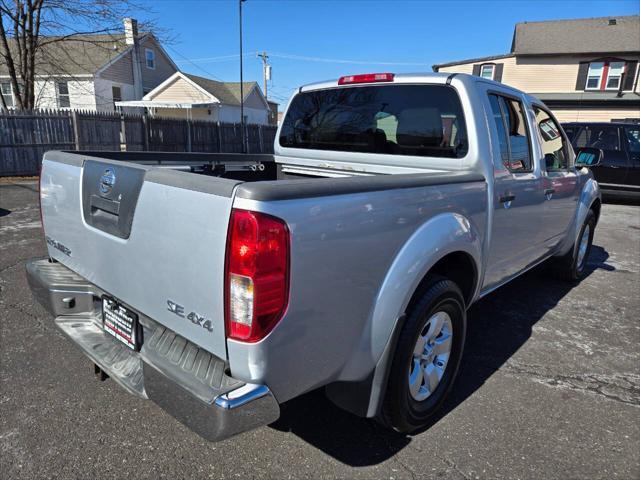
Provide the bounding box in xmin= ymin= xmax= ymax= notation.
xmin=433 ymin=15 xmax=640 ymax=122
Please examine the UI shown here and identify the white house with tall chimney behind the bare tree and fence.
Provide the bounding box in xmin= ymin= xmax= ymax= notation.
xmin=0 ymin=18 xmax=178 ymax=111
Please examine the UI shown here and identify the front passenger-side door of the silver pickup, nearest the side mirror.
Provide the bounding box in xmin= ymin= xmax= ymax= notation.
xmin=533 ymin=104 xmax=579 ymax=249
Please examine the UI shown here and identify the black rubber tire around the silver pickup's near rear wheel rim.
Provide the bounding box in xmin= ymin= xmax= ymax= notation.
xmin=381 ymin=276 xmax=467 ymax=433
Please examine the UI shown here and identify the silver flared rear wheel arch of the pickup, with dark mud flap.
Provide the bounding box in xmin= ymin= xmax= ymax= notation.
xmin=327 ymin=212 xmax=483 ymax=417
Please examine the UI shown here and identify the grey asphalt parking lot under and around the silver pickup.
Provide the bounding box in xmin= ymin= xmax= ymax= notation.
xmin=0 ymin=183 xmax=640 ymax=479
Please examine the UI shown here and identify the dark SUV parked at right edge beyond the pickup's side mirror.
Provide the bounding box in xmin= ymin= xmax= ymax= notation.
xmin=563 ymin=122 xmax=640 ymax=200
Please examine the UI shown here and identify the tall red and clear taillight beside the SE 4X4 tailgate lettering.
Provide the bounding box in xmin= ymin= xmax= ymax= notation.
xmin=225 ymin=209 xmax=289 ymax=342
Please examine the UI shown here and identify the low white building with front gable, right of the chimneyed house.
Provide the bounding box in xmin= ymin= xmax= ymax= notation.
xmin=118 ymin=72 xmax=271 ymax=125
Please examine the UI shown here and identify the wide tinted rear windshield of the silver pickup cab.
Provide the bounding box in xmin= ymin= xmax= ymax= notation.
xmin=279 ymin=85 xmax=468 ymax=158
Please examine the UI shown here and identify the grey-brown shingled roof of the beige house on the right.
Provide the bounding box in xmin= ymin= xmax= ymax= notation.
xmin=511 ymin=15 xmax=640 ymax=55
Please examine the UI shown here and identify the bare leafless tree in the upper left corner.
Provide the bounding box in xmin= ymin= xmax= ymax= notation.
xmin=0 ymin=0 xmax=159 ymax=110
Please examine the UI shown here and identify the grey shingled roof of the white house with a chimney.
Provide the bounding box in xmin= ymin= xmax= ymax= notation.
xmin=0 ymin=34 xmax=129 ymax=76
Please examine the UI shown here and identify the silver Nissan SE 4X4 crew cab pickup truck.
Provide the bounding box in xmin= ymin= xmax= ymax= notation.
xmin=27 ymin=73 xmax=601 ymax=440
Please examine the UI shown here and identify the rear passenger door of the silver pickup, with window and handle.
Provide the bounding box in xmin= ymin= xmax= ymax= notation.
xmin=484 ymin=91 xmax=545 ymax=290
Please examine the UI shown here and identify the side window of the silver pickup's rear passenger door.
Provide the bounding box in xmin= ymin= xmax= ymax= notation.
xmin=489 ymin=94 xmax=532 ymax=172
